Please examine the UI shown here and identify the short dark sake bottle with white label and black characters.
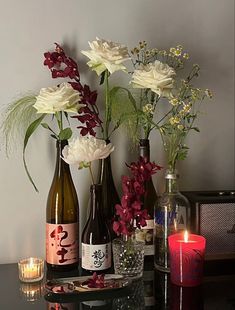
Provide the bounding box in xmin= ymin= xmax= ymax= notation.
xmin=82 ymin=184 xmax=111 ymax=273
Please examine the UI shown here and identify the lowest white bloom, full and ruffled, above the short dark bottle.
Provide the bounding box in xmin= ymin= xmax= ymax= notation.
xmin=62 ymin=136 xmax=114 ymax=167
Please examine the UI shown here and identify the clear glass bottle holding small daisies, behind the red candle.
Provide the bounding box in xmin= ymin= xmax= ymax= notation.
xmin=154 ymin=170 xmax=190 ymax=272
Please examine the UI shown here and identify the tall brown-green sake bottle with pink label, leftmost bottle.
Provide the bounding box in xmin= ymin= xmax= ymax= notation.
xmin=46 ymin=141 xmax=79 ymax=271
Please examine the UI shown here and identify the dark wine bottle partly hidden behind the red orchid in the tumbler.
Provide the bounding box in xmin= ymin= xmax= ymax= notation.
xmin=136 ymin=139 xmax=157 ymax=258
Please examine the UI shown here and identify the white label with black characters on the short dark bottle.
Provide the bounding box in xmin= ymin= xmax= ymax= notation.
xmin=82 ymin=242 xmax=111 ymax=270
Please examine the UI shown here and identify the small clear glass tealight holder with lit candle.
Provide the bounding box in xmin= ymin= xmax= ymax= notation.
xmin=18 ymin=257 xmax=44 ymax=282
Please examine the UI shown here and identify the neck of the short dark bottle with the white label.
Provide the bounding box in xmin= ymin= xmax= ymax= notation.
xmin=90 ymin=184 xmax=102 ymax=220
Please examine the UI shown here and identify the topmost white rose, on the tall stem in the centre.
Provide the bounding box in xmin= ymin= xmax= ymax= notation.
xmin=82 ymin=38 xmax=130 ymax=75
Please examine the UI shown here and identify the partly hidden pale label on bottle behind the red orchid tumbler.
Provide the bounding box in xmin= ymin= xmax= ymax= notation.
xmin=135 ymin=219 xmax=154 ymax=255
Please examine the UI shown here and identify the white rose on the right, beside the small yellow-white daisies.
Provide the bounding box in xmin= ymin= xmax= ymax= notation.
xmin=131 ymin=60 xmax=176 ymax=98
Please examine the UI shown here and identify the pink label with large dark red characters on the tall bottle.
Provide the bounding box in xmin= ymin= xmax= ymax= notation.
xmin=46 ymin=223 xmax=79 ymax=265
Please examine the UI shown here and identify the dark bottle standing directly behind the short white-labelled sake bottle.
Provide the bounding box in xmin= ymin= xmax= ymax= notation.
xmin=97 ymin=140 xmax=120 ymax=239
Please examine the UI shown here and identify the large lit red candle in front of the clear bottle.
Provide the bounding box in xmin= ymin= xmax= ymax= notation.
xmin=168 ymin=231 xmax=206 ymax=286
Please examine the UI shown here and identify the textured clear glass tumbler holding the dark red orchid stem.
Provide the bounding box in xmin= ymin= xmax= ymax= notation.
xmin=112 ymin=235 xmax=145 ymax=279
